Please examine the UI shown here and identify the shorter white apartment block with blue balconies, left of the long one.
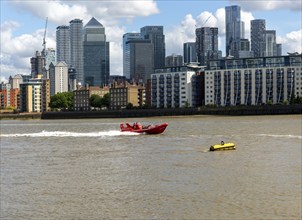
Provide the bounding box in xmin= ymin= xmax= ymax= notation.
xmin=151 ymin=66 xmax=195 ymax=108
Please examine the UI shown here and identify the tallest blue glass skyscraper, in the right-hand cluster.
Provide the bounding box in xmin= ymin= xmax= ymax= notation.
xmin=225 ymin=5 xmax=244 ymax=58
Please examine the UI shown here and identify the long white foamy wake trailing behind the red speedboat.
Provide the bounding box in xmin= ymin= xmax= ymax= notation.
xmin=0 ymin=130 xmax=139 ymax=137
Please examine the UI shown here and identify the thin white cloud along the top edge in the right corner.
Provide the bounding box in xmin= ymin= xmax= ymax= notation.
xmin=230 ymin=0 xmax=302 ymax=11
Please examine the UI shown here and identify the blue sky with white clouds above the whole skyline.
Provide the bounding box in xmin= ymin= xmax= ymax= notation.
xmin=0 ymin=0 xmax=302 ymax=82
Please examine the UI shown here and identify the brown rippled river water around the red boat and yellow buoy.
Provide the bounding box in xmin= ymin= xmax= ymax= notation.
xmin=0 ymin=115 xmax=302 ymax=219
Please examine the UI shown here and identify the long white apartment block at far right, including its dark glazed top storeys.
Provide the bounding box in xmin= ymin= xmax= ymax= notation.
xmin=205 ymin=55 xmax=302 ymax=106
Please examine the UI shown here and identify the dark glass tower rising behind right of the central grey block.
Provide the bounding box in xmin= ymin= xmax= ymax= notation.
xmin=141 ymin=26 xmax=166 ymax=68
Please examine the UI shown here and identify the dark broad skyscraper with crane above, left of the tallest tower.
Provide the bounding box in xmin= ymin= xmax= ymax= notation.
xmin=196 ymin=27 xmax=219 ymax=65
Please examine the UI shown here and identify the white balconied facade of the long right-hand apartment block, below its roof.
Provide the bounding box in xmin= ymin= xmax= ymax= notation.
xmin=205 ymin=64 xmax=302 ymax=106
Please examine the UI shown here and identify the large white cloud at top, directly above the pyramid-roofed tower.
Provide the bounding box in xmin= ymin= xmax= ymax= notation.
xmin=10 ymin=0 xmax=159 ymax=25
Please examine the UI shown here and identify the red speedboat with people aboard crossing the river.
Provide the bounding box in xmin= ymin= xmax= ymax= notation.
xmin=120 ymin=122 xmax=168 ymax=134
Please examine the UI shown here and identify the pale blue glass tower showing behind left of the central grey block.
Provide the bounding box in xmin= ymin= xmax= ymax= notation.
xmin=123 ymin=33 xmax=141 ymax=79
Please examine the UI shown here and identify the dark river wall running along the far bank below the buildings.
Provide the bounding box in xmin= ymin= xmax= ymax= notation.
xmin=0 ymin=105 xmax=302 ymax=120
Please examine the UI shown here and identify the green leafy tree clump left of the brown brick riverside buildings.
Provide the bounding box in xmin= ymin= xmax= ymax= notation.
xmin=49 ymin=92 xmax=73 ymax=109
